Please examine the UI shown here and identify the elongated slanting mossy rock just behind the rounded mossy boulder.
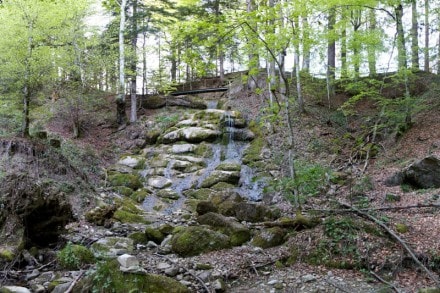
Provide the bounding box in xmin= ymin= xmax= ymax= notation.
xmin=197 ymin=212 xmax=251 ymax=246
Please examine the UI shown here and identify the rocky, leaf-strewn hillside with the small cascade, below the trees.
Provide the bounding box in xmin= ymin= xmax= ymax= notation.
xmin=0 ymin=73 xmax=440 ymax=292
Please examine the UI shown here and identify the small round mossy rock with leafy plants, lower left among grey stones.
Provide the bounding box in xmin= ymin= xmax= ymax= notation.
xmin=57 ymin=242 xmax=95 ymax=270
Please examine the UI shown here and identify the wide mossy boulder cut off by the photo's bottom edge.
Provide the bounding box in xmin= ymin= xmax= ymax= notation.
xmin=81 ymin=260 xmax=190 ymax=293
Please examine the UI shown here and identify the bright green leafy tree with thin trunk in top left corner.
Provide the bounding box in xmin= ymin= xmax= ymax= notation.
xmin=0 ymin=0 xmax=91 ymax=137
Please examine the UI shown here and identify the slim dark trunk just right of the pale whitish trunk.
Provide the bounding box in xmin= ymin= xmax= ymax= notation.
xmin=130 ymin=0 xmax=138 ymax=122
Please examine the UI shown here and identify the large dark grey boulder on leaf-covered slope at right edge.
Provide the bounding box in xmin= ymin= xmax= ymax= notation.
xmin=385 ymin=156 xmax=440 ymax=189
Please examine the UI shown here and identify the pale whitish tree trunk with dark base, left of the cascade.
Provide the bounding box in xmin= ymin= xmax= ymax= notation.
xmin=116 ymin=0 xmax=127 ymax=125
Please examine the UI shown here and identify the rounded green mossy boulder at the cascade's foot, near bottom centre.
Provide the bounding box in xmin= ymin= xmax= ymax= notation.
xmin=171 ymin=226 xmax=231 ymax=257
